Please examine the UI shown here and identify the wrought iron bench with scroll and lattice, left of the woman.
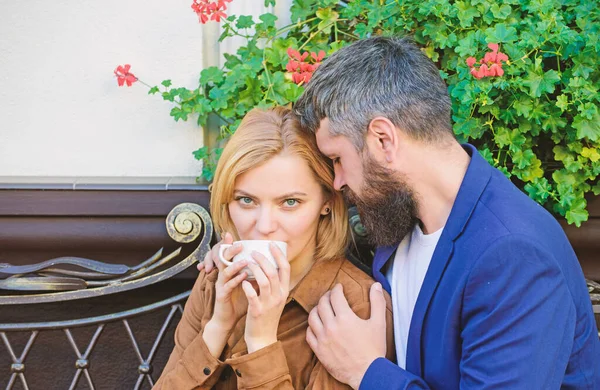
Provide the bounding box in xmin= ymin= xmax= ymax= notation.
xmin=0 ymin=203 xmax=213 ymax=389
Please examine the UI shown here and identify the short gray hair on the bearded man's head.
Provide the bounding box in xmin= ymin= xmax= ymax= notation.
xmin=294 ymin=37 xmax=454 ymax=151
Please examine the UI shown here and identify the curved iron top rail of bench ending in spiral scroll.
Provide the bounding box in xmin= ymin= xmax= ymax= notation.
xmin=0 ymin=203 xmax=213 ymax=305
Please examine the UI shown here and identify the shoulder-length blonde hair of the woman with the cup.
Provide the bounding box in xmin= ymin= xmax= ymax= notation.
xmin=210 ymin=107 xmax=348 ymax=260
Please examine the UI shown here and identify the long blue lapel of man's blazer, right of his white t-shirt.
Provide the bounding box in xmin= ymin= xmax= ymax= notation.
xmin=404 ymin=144 xmax=492 ymax=376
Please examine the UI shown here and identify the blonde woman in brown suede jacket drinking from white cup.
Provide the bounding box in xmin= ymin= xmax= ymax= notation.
xmin=155 ymin=107 xmax=394 ymax=389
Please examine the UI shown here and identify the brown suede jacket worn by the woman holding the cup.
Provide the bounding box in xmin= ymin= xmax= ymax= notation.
xmin=154 ymin=259 xmax=395 ymax=390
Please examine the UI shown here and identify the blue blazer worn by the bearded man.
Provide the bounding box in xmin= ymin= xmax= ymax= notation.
xmin=360 ymin=145 xmax=600 ymax=390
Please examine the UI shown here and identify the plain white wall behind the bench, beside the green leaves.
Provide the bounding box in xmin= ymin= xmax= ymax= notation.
xmin=0 ymin=0 xmax=289 ymax=177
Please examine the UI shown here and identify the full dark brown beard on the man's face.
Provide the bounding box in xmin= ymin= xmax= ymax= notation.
xmin=342 ymin=155 xmax=417 ymax=246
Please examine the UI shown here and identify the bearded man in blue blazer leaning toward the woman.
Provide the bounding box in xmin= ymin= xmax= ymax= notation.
xmin=295 ymin=37 xmax=600 ymax=389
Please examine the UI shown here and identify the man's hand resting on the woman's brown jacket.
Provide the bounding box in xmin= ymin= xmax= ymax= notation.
xmin=306 ymin=283 xmax=386 ymax=389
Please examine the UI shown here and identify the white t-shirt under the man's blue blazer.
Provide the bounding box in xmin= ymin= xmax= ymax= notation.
xmin=386 ymin=223 xmax=444 ymax=368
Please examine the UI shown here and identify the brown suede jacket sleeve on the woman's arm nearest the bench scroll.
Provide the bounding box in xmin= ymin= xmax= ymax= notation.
xmin=153 ymin=271 xmax=229 ymax=390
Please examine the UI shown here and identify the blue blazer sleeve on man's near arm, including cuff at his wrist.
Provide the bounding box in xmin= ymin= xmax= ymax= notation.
xmin=360 ymin=235 xmax=575 ymax=390
